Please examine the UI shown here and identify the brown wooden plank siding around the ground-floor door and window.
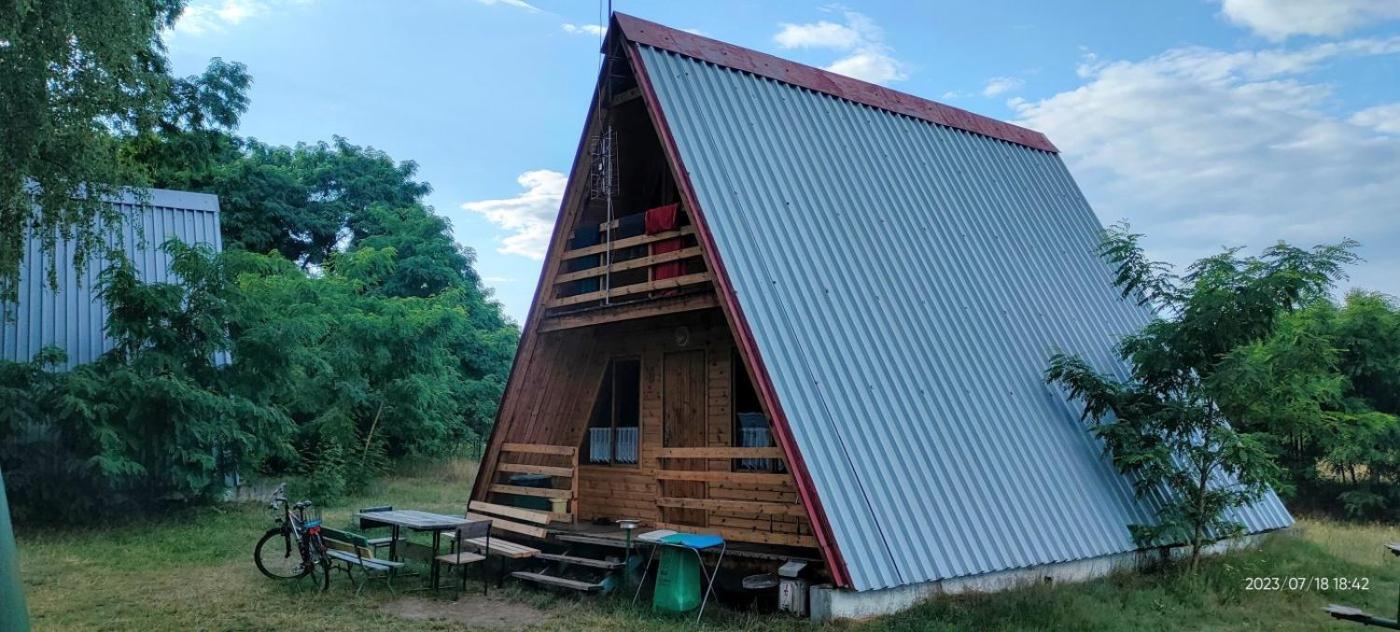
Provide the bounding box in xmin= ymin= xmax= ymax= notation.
xmin=478 ymin=308 xmax=812 ymax=545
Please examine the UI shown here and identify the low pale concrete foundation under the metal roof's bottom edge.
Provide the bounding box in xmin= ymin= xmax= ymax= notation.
xmin=808 ymin=535 xmax=1260 ymax=622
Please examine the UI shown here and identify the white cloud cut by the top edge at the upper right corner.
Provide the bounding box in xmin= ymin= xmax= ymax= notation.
xmin=1221 ymin=0 xmax=1400 ymax=42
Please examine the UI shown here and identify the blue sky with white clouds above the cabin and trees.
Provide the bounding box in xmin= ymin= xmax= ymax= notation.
xmin=165 ymin=0 xmax=1400 ymax=322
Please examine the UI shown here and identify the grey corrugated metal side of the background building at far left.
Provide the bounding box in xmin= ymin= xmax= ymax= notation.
xmin=0 ymin=189 xmax=223 ymax=367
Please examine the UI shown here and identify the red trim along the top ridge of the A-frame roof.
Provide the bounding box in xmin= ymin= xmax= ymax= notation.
xmin=613 ymin=13 xmax=1060 ymax=153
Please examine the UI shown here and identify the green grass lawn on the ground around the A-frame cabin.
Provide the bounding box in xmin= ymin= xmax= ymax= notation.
xmin=20 ymin=461 xmax=1400 ymax=632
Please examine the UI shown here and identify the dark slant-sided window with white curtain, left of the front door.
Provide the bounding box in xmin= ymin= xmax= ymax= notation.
xmin=585 ymin=357 xmax=641 ymax=465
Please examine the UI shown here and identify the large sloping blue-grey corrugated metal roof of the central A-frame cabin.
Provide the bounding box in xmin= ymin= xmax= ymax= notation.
xmin=637 ymin=43 xmax=1292 ymax=590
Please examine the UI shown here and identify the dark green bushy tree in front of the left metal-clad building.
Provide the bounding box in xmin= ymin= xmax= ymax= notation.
xmin=0 ymin=241 xmax=293 ymax=520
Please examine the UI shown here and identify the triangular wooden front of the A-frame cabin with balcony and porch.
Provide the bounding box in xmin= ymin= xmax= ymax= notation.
xmin=472 ymin=32 xmax=819 ymax=551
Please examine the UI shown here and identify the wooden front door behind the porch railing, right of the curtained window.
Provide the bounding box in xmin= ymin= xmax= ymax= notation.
xmin=661 ymin=350 xmax=706 ymax=527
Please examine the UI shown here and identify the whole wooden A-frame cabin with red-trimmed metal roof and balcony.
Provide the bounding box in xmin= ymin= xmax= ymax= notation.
xmin=472 ymin=14 xmax=1291 ymax=617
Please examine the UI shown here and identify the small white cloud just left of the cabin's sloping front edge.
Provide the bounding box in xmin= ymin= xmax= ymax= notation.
xmin=462 ymin=170 xmax=568 ymax=259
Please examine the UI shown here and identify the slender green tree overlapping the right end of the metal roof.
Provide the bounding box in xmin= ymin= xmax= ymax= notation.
xmin=1046 ymin=226 xmax=1355 ymax=570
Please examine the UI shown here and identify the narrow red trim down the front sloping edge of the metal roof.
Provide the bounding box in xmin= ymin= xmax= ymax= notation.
xmin=623 ymin=33 xmax=851 ymax=587
